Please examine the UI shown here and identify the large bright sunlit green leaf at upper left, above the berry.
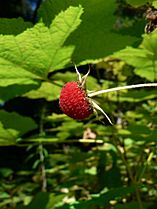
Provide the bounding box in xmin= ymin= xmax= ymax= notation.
xmin=0 ymin=6 xmax=83 ymax=86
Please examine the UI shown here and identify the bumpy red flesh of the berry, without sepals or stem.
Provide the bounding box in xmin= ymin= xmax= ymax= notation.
xmin=59 ymin=82 xmax=93 ymax=120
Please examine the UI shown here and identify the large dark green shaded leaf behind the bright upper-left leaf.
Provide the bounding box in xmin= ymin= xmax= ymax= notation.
xmin=39 ymin=0 xmax=144 ymax=63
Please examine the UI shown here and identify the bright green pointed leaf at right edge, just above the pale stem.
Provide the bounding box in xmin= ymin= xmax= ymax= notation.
xmin=113 ymin=30 xmax=157 ymax=81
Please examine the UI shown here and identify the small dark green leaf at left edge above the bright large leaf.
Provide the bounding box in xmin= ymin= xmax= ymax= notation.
xmin=0 ymin=17 xmax=33 ymax=35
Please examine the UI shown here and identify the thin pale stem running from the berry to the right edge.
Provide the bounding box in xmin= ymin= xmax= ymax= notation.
xmin=88 ymin=83 xmax=157 ymax=97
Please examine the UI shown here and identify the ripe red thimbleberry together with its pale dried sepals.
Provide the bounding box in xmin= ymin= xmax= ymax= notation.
xmin=59 ymin=66 xmax=112 ymax=124
